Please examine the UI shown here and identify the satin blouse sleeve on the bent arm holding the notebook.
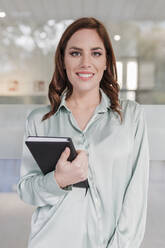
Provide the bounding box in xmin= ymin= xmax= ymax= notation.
xmin=17 ymin=113 xmax=71 ymax=207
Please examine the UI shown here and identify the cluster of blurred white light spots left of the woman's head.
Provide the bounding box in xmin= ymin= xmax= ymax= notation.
xmin=2 ymin=20 xmax=73 ymax=54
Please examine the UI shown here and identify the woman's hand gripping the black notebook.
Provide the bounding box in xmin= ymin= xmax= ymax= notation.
xmin=54 ymin=147 xmax=88 ymax=188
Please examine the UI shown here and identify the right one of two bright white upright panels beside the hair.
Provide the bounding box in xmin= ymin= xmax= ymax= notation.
xmin=127 ymin=61 xmax=138 ymax=90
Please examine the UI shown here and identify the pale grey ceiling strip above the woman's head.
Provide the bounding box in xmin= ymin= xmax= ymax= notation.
xmin=0 ymin=0 xmax=165 ymax=27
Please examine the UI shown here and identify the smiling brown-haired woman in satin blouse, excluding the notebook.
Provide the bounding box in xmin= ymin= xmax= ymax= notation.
xmin=18 ymin=18 xmax=149 ymax=248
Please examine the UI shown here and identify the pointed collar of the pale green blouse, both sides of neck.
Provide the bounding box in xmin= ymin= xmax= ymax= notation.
xmin=56 ymin=88 xmax=110 ymax=113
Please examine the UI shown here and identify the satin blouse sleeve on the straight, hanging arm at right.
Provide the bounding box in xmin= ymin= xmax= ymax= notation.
xmin=107 ymin=104 xmax=149 ymax=248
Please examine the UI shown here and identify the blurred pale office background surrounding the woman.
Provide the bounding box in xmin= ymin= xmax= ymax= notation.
xmin=0 ymin=0 xmax=165 ymax=248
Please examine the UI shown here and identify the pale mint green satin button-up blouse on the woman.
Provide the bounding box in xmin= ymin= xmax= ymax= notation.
xmin=17 ymin=89 xmax=149 ymax=248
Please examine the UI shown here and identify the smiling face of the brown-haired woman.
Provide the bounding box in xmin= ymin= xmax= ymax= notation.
xmin=64 ymin=29 xmax=106 ymax=92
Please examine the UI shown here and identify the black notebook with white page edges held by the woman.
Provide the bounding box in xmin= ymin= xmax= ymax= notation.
xmin=25 ymin=136 xmax=89 ymax=190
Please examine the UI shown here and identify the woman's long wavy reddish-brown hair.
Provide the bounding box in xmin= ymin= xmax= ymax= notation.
xmin=42 ymin=17 xmax=122 ymax=121
